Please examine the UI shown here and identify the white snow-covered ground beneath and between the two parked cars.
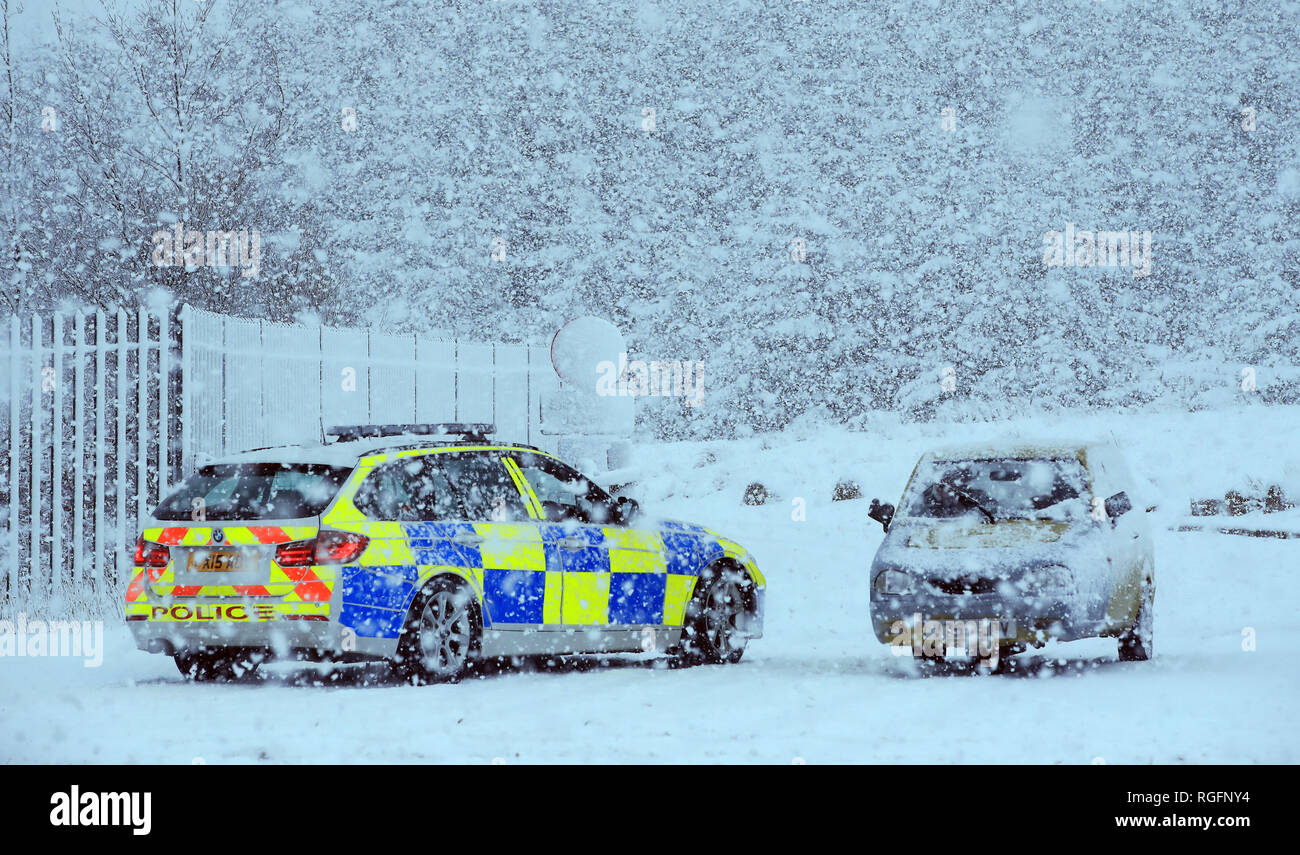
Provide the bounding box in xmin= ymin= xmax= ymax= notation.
xmin=0 ymin=408 xmax=1300 ymax=764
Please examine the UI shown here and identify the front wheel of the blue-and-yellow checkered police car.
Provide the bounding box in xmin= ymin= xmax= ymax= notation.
xmin=673 ymin=564 xmax=753 ymax=665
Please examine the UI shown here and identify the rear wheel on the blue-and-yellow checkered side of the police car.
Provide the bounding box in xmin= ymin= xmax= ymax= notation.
xmin=397 ymin=577 xmax=482 ymax=685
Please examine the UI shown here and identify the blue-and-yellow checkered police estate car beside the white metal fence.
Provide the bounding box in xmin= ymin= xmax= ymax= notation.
xmin=126 ymin=425 xmax=766 ymax=682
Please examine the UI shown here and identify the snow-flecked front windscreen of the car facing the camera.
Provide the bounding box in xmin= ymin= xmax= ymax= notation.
xmin=902 ymin=457 xmax=1091 ymax=521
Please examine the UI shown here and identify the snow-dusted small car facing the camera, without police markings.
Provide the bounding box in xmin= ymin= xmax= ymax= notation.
xmin=868 ymin=443 xmax=1156 ymax=664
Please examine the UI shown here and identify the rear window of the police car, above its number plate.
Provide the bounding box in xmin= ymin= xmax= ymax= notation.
xmin=153 ymin=463 xmax=352 ymax=520
